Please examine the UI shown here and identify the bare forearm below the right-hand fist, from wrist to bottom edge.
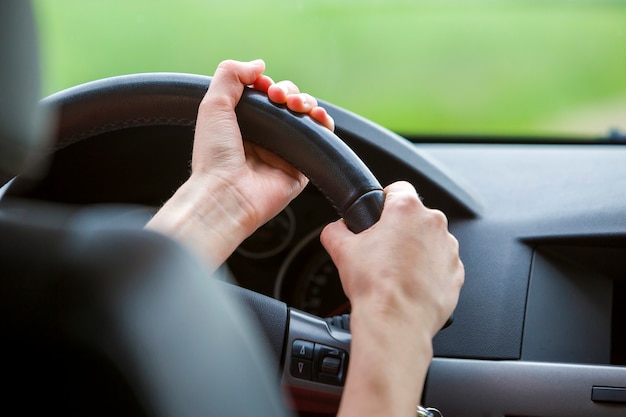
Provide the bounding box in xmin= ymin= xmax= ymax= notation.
xmin=338 ymin=306 xmax=432 ymax=417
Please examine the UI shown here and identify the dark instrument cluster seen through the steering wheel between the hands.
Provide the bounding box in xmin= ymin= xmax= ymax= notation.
xmin=227 ymin=187 xmax=350 ymax=317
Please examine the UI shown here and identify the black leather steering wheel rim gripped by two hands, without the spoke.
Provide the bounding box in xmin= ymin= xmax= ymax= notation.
xmin=42 ymin=73 xmax=384 ymax=233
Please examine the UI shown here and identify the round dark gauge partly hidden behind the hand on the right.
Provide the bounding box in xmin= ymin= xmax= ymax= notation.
xmin=275 ymin=230 xmax=350 ymax=317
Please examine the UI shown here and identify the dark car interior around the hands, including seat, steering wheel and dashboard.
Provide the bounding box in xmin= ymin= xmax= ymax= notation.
xmin=0 ymin=1 xmax=626 ymax=417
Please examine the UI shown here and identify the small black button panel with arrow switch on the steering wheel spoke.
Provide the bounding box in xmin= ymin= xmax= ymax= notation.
xmin=290 ymin=340 xmax=348 ymax=386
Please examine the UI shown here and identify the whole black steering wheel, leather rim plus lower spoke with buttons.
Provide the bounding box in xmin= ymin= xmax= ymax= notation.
xmin=7 ymin=73 xmax=383 ymax=412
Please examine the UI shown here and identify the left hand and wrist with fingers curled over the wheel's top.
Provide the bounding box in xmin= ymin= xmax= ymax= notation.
xmin=147 ymin=60 xmax=334 ymax=267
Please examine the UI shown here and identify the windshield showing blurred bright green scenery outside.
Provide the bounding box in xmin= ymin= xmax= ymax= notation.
xmin=34 ymin=0 xmax=626 ymax=138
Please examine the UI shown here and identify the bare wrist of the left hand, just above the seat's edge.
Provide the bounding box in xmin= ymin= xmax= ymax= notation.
xmin=146 ymin=176 xmax=254 ymax=271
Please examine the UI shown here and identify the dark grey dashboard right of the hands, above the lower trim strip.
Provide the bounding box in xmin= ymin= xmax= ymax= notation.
xmin=420 ymin=141 xmax=626 ymax=364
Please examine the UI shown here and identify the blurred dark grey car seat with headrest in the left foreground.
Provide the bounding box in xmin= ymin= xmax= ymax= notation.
xmin=0 ymin=0 xmax=286 ymax=417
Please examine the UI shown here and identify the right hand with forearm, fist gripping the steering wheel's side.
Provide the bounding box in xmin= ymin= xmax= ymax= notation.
xmin=321 ymin=182 xmax=464 ymax=417
